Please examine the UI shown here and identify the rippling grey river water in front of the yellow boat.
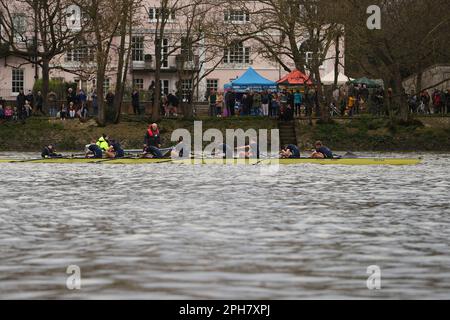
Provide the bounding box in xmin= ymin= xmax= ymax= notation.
xmin=0 ymin=154 xmax=450 ymax=299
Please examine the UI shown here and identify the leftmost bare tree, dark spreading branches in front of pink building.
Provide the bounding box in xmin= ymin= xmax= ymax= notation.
xmin=0 ymin=0 xmax=83 ymax=103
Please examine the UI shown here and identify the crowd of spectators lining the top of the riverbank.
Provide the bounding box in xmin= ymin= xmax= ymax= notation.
xmin=0 ymin=84 xmax=450 ymax=122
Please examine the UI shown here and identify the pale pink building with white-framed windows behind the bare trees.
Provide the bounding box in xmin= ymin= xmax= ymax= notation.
xmin=0 ymin=0 xmax=344 ymax=101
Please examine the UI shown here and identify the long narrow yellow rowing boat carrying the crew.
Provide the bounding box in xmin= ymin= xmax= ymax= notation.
xmin=0 ymin=158 xmax=422 ymax=166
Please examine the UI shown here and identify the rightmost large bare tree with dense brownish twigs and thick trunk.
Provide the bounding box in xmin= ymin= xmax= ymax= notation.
xmin=341 ymin=0 xmax=450 ymax=121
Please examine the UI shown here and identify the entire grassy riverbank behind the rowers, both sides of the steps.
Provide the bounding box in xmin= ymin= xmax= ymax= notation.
xmin=0 ymin=118 xmax=450 ymax=151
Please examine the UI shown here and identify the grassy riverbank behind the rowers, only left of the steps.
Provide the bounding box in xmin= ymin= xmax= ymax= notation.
xmin=0 ymin=118 xmax=277 ymax=151
